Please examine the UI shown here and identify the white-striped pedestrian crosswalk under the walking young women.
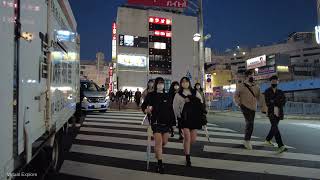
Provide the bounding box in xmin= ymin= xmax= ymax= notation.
xmin=60 ymin=111 xmax=320 ymax=180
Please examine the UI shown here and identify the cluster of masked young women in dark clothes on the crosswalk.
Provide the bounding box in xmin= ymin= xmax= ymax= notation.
xmin=141 ymin=77 xmax=207 ymax=173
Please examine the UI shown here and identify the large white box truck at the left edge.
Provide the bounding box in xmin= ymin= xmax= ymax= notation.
xmin=0 ymin=0 xmax=80 ymax=180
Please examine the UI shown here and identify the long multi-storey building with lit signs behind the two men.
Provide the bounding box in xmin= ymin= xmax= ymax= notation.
xmin=206 ymin=32 xmax=320 ymax=102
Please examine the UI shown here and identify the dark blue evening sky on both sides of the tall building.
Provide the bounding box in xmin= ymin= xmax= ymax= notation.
xmin=69 ymin=0 xmax=317 ymax=61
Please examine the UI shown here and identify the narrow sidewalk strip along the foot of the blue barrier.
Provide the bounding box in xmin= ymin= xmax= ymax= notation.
xmin=209 ymin=110 xmax=320 ymax=121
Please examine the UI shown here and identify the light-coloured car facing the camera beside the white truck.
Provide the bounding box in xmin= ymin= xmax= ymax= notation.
xmin=80 ymin=80 xmax=110 ymax=112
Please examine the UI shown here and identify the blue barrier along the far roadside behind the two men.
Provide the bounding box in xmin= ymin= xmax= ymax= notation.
xmin=208 ymin=97 xmax=320 ymax=115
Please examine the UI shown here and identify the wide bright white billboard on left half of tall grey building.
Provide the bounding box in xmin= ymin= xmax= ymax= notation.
xmin=118 ymin=54 xmax=147 ymax=67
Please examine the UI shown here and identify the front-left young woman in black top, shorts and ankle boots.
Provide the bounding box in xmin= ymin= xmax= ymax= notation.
xmin=141 ymin=77 xmax=176 ymax=174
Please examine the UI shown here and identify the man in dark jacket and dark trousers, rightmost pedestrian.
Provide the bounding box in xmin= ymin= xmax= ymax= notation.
xmin=265 ymin=76 xmax=288 ymax=153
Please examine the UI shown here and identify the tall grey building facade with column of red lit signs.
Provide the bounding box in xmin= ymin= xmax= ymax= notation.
xmin=114 ymin=6 xmax=199 ymax=91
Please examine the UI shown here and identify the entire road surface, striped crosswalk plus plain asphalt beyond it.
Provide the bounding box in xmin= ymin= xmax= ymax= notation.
xmin=18 ymin=112 xmax=320 ymax=180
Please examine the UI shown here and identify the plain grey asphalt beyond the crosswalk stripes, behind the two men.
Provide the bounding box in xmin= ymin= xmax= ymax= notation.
xmin=208 ymin=113 xmax=320 ymax=155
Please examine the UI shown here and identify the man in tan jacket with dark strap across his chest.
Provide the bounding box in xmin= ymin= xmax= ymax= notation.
xmin=234 ymin=70 xmax=261 ymax=150
